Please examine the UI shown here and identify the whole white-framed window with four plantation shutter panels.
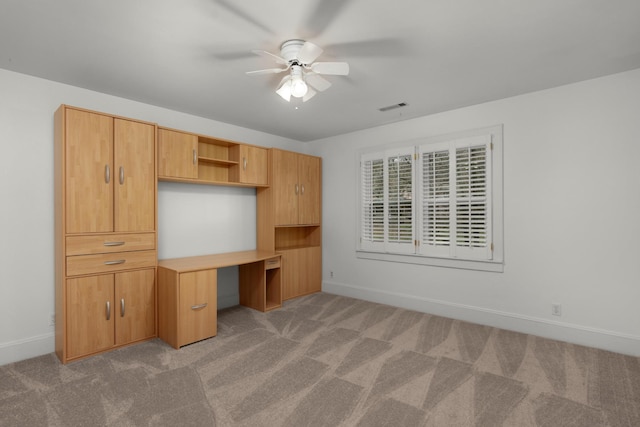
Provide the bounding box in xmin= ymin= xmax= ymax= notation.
xmin=358 ymin=127 xmax=502 ymax=267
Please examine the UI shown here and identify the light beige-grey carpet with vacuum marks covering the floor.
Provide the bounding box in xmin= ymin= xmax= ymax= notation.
xmin=0 ymin=293 xmax=640 ymax=427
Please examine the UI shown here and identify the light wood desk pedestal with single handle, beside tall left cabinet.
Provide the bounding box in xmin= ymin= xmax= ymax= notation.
xmin=158 ymin=267 xmax=218 ymax=348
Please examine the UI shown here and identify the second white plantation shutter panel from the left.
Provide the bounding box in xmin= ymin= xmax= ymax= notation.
xmin=385 ymin=147 xmax=415 ymax=253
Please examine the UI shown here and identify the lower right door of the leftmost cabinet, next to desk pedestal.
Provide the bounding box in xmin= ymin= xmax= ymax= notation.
xmin=114 ymin=269 xmax=156 ymax=345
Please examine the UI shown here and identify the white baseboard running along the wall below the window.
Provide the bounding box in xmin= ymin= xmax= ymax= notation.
xmin=322 ymin=281 xmax=640 ymax=356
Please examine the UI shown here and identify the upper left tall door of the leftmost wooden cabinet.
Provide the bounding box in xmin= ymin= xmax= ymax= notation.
xmin=64 ymin=109 xmax=114 ymax=233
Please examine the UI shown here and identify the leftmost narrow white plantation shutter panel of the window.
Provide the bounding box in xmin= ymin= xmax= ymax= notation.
xmin=360 ymin=154 xmax=384 ymax=250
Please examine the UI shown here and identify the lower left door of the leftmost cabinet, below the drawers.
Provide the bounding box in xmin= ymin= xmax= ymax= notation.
xmin=65 ymin=274 xmax=115 ymax=358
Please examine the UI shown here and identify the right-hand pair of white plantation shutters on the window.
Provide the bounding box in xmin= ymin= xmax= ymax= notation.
xmin=418 ymin=135 xmax=492 ymax=259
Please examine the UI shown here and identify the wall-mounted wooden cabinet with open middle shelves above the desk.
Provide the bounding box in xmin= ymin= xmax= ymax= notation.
xmin=158 ymin=128 xmax=269 ymax=187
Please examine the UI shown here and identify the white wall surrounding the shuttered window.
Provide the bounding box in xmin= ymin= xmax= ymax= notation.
xmin=311 ymin=70 xmax=640 ymax=355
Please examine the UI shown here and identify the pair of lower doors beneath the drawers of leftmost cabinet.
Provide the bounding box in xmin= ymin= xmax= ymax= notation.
xmin=65 ymin=269 xmax=156 ymax=360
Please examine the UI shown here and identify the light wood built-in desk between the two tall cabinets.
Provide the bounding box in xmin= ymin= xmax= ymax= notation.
xmin=158 ymin=251 xmax=282 ymax=348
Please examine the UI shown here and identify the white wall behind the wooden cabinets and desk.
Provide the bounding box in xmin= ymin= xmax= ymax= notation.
xmin=0 ymin=69 xmax=307 ymax=365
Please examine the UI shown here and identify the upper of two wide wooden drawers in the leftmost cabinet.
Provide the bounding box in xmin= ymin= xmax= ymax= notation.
xmin=66 ymin=233 xmax=156 ymax=256
